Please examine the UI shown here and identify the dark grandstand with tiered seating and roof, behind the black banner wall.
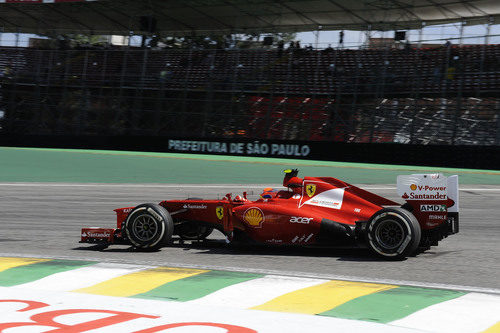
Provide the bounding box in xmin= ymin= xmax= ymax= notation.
xmin=0 ymin=0 xmax=500 ymax=163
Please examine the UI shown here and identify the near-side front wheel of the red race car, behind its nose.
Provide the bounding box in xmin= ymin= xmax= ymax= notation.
xmin=123 ymin=203 xmax=174 ymax=250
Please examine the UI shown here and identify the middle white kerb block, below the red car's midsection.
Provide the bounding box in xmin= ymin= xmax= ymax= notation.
xmin=186 ymin=275 xmax=326 ymax=309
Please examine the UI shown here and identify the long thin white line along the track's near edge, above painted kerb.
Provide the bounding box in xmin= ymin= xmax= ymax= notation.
xmin=0 ymin=253 xmax=500 ymax=295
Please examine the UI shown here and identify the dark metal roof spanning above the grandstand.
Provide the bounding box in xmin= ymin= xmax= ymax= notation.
xmin=0 ymin=0 xmax=500 ymax=36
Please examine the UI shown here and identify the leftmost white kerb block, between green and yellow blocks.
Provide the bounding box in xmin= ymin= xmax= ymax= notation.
xmin=14 ymin=263 xmax=148 ymax=291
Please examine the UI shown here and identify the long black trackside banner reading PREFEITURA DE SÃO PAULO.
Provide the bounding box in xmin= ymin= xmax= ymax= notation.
xmin=0 ymin=133 xmax=500 ymax=169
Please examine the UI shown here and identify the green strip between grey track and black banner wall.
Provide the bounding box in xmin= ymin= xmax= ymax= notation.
xmin=0 ymin=147 xmax=500 ymax=185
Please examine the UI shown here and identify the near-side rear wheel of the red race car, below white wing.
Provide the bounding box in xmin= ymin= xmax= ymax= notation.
xmin=367 ymin=208 xmax=422 ymax=260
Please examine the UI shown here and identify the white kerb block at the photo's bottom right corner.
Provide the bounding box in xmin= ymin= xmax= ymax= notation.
xmin=389 ymin=293 xmax=500 ymax=333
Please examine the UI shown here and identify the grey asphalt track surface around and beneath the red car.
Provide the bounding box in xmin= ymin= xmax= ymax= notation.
xmin=0 ymin=183 xmax=500 ymax=293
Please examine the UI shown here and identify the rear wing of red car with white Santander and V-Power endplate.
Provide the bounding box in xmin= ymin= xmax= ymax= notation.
xmin=397 ymin=173 xmax=460 ymax=233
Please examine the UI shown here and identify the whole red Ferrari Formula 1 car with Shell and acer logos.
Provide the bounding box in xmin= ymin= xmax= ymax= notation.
xmin=81 ymin=170 xmax=458 ymax=259
